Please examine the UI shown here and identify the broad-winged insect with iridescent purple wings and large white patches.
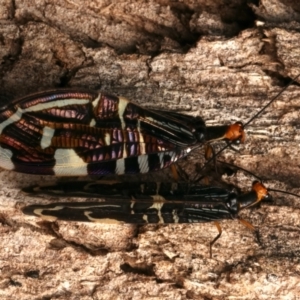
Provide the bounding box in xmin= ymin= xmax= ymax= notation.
xmin=0 ymin=89 xmax=244 ymax=176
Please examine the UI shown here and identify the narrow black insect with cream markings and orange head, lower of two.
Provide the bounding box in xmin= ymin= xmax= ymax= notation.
xmin=22 ymin=181 xmax=270 ymax=257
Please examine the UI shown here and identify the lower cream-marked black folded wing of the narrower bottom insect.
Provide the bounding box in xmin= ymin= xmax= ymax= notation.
xmin=23 ymin=199 xmax=233 ymax=224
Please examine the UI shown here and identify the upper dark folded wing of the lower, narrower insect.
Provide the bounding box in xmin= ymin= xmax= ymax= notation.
xmin=23 ymin=180 xmax=233 ymax=202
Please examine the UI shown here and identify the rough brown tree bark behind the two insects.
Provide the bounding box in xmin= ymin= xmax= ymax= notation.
xmin=0 ymin=0 xmax=300 ymax=300
